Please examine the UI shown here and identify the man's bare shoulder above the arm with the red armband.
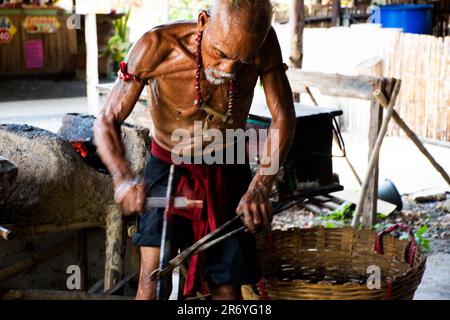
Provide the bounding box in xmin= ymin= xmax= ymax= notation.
xmin=127 ymin=21 xmax=196 ymax=79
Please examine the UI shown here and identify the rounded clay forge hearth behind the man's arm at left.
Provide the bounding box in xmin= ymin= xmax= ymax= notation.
xmin=0 ymin=114 xmax=149 ymax=226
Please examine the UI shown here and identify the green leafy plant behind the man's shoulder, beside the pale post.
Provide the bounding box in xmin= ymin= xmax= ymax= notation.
xmin=108 ymin=11 xmax=131 ymax=64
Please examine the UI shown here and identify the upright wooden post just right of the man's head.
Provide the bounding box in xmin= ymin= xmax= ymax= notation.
xmin=289 ymin=0 xmax=305 ymax=68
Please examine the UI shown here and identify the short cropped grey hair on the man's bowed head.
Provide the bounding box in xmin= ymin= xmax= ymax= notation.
xmin=209 ymin=0 xmax=274 ymax=36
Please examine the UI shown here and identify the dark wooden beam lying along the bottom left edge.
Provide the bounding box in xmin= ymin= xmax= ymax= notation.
xmin=0 ymin=289 xmax=134 ymax=300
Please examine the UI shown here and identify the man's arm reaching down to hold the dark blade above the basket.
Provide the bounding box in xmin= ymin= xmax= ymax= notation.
xmin=236 ymin=28 xmax=296 ymax=232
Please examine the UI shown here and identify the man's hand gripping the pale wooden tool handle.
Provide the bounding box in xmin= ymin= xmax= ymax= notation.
xmin=114 ymin=179 xmax=145 ymax=216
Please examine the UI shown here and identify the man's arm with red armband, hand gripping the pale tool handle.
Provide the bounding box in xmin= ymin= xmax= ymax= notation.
xmin=94 ymin=32 xmax=161 ymax=214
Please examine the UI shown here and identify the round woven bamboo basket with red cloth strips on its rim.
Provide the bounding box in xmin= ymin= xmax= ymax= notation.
xmin=257 ymin=225 xmax=426 ymax=300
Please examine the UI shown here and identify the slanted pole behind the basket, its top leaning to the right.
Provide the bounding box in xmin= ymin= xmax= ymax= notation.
xmin=352 ymin=80 xmax=401 ymax=228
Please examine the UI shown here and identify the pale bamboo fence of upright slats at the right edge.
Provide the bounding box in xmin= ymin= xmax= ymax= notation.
xmin=384 ymin=33 xmax=450 ymax=141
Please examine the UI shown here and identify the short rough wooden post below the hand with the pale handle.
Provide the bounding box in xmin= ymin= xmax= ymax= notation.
xmin=104 ymin=206 xmax=126 ymax=291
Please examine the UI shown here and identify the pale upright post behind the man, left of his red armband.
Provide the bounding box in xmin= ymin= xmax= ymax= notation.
xmin=85 ymin=13 xmax=99 ymax=115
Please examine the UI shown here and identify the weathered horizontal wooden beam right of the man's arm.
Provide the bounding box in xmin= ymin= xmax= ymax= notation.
xmin=287 ymin=69 xmax=379 ymax=100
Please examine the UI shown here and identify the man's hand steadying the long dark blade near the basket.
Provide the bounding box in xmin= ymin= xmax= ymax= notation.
xmin=236 ymin=188 xmax=272 ymax=233
